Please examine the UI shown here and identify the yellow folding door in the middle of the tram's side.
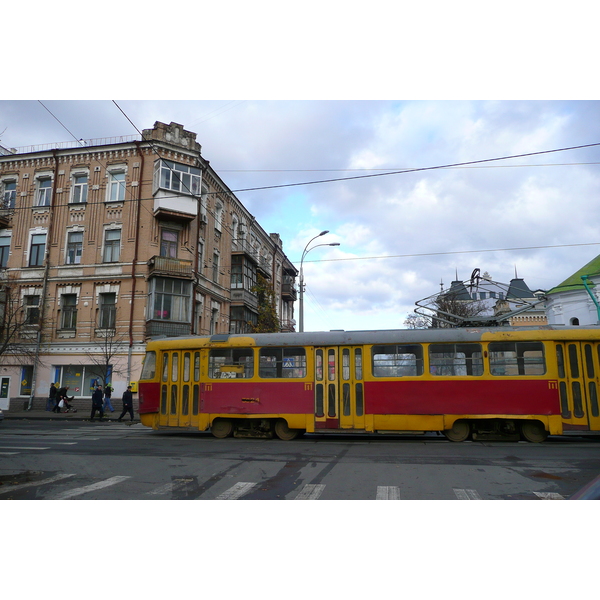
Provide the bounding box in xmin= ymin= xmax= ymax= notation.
xmin=315 ymin=346 xmax=365 ymax=430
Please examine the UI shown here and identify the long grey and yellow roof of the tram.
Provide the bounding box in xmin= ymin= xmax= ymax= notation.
xmin=145 ymin=325 xmax=600 ymax=348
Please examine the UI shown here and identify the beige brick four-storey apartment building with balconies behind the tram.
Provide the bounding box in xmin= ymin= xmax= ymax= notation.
xmin=0 ymin=122 xmax=298 ymax=410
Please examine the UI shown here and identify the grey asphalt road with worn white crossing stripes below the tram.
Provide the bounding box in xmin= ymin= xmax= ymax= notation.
xmin=0 ymin=420 xmax=600 ymax=501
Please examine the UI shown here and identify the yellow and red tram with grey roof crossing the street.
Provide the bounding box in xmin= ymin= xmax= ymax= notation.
xmin=139 ymin=326 xmax=600 ymax=442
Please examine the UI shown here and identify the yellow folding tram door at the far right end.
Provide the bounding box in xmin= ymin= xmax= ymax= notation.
xmin=556 ymin=342 xmax=600 ymax=431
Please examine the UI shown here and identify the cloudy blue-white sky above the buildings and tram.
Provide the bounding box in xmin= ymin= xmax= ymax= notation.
xmin=0 ymin=100 xmax=600 ymax=330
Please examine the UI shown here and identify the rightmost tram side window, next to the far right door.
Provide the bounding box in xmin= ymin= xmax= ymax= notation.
xmin=488 ymin=342 xmax=546 ymax=376
